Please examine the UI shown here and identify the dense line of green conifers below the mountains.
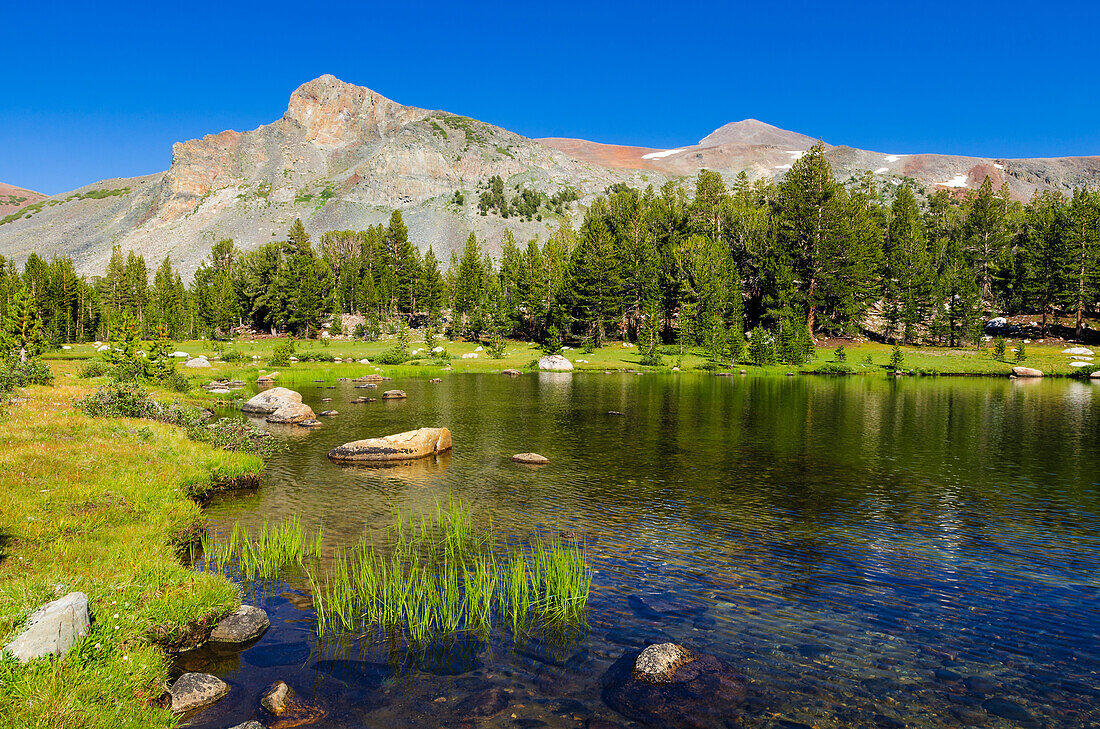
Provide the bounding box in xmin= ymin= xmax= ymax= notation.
xmin=0 ymin=145 xmax=1100 ymax=362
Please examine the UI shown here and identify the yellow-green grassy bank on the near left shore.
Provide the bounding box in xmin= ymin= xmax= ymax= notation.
xmin=0 ymin=377 xmax=262 ymax=728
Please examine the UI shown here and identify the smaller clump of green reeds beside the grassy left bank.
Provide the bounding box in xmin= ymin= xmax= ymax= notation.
xmin=202 ymin=517 xmax=323 ymax=581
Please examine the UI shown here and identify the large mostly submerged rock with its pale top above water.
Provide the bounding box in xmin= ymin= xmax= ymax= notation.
xmin=603 ymin=643 xmax=747 ymax=729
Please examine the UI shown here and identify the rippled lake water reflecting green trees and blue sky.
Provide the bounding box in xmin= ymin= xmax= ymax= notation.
xmin=177 ymin=367 xmax=1100 ymax=728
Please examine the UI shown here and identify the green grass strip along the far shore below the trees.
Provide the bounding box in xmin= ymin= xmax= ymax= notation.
xmin=42 ymin=335 xmax=1091 ymax=382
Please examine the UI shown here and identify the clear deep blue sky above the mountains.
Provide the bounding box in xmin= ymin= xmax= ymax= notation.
xmin=0 ymin=0 xmax=1100 ymax=194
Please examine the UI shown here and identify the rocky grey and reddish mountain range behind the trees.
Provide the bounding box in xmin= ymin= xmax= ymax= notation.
xmin=0 ymin=76 xmax=1100 ymax=278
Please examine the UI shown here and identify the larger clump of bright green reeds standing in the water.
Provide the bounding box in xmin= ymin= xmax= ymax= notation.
xmin=309 ymin=502 xmax=592 ymax=643
